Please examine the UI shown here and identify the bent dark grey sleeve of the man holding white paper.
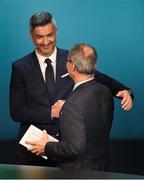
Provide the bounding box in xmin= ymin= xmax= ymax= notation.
xmin=45 ymin=100 xmax=86 ymax=159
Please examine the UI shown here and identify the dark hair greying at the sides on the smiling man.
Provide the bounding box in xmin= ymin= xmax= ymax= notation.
xmin=29 ymin=12 xmax=57 ymax=31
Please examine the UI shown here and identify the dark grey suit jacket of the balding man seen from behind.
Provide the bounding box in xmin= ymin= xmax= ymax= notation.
xmin=45 ymin=80 xmax=113 ymax=170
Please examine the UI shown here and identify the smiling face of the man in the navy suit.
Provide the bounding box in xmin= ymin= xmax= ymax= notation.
xmin=31 ymin=23 xmax=57 ymax=56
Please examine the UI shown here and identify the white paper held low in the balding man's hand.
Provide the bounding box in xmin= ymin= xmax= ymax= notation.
xmin=19 ymin=125 xmax=58 ymax=159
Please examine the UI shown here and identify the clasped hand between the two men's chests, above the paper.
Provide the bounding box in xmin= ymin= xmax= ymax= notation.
xmin=51 ymin=100 xmax=65 ymax=118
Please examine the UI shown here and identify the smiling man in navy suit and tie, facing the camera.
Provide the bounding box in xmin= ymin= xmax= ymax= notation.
xmin=10 ymin=12 xmax=132 ymax=166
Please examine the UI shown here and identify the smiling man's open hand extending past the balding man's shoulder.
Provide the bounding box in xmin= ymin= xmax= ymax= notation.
xmin=116 ymin=90 xmax=133 ymax=111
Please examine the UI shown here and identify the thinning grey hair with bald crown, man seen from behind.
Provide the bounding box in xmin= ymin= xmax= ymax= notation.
xmin=68 ymin=43 xmax=97 ymax=75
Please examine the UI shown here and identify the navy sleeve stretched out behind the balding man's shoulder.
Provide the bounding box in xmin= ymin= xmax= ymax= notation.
xmin=95 ymin=71 xmax=134 ymax=99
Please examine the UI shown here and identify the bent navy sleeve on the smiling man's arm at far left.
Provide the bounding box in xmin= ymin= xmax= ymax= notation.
xmin=10 ymin=64 xmax=51 ymax=123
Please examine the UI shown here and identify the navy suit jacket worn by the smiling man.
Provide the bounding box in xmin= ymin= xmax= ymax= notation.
xmin=10 ymin=48 xmax=128 ymax=165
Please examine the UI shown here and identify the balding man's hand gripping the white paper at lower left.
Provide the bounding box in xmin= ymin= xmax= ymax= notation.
xmin=25 ymin=130 xmax=48 ymax=155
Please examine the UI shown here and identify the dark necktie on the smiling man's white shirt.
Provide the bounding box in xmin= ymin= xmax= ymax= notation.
xmin=45 ymin=59 xmax=55 ymax=98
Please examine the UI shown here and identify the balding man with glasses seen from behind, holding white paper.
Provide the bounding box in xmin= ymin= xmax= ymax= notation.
xmin=25 ymin=44 xmax=113 ymax=170
